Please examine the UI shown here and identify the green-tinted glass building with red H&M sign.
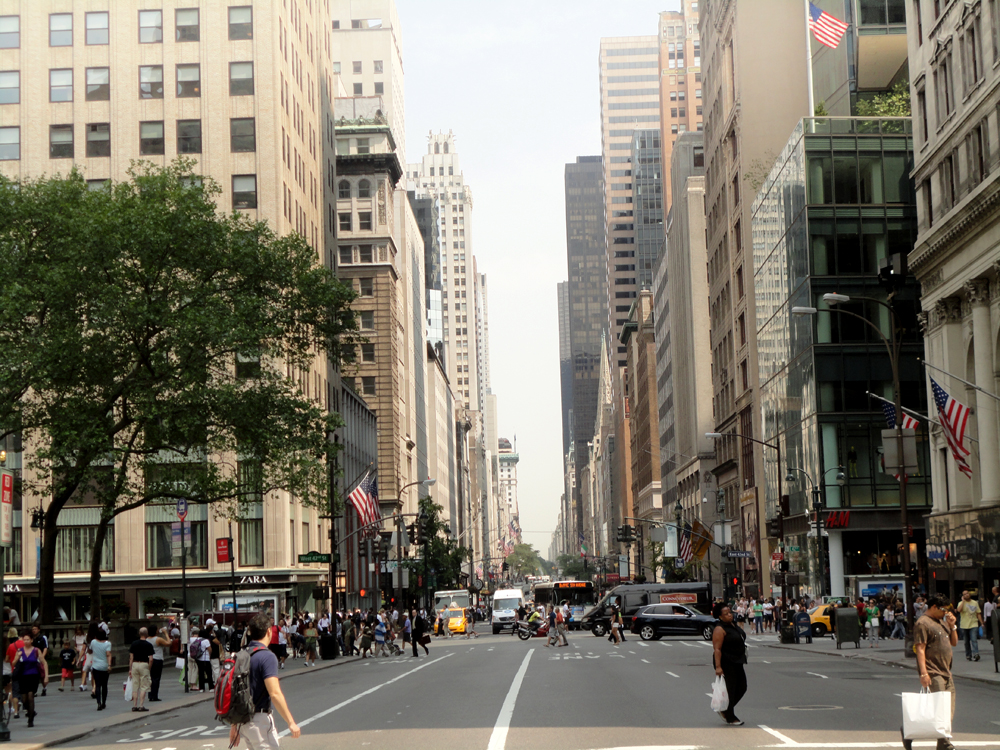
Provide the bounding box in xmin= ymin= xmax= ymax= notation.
xmin=752 ymin=118 xmax=931 ymax=596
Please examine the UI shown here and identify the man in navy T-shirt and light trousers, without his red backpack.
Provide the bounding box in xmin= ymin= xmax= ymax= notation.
xmin=229 ymin=614 xmax=302 ymax=750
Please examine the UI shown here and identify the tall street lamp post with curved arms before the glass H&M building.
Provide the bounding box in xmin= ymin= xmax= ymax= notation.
xmin=791 ymin=293 xmax=914 ymax=656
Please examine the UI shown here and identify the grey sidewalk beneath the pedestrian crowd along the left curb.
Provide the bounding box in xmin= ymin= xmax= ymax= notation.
xmin=2 ymin=656 xmax=361 ymax=750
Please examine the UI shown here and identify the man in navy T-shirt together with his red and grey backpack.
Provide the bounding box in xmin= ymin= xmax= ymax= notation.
xmin=224 ymin=614 xmax=302 ymax=750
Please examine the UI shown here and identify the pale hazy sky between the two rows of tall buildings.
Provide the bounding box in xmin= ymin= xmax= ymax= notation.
xmin=396 ymin=0 xmax=679 ymax=556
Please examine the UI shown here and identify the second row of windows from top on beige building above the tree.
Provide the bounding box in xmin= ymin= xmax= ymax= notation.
xmin=0 ymin=62 xmax=254 ymax=104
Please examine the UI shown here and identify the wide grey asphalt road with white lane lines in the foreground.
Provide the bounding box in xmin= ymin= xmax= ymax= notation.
xmin=76 ymin=633 xmax=1000 ymax=750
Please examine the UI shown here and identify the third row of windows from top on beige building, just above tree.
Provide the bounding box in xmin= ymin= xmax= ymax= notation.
xmin=0 ymin=117 xmax=257 ymax=161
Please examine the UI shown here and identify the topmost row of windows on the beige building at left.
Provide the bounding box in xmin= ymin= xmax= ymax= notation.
xmin=0 ymin=5 xmax=253 ymax=49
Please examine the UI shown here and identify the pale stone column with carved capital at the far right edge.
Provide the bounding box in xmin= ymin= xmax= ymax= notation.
xmin=965 ymin=279 xmax=1000 ymax=505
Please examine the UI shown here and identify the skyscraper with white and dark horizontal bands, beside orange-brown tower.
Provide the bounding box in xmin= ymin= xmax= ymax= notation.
xmin=599 ymin=36 xmax=660 ymax=368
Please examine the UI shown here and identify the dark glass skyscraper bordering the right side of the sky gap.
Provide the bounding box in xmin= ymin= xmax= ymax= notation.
xmin=565 ymin=156 xmax=607 ymax=544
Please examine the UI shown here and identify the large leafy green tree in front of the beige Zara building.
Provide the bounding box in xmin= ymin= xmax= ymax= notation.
xmin=0 ymin=160 xmax=356 ymax=622
